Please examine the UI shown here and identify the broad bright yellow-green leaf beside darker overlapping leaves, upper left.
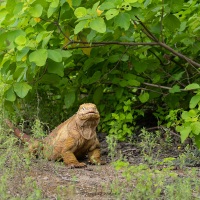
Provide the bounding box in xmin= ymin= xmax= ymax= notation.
xmin=29 ymin=49 xmax=48 ymax=67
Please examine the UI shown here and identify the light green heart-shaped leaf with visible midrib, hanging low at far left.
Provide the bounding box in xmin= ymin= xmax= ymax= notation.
xmin=13 ymin=82 xmax=32 ymax=98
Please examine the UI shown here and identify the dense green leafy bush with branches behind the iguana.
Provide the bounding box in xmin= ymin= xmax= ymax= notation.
xmin=0 ymin=0 xmax=200 ymax=146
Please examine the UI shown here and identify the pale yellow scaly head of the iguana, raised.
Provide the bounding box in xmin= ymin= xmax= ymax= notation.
xmin=77 ymin=103 xmax=100 ymax=120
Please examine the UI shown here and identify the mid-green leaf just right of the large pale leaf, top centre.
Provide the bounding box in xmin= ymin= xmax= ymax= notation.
xmin=115 ymin=12 xmax=131 ymax=31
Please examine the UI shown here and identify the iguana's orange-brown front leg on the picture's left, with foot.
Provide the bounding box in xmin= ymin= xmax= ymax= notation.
xmin=61 ymin=138 xmax=86 ymax=167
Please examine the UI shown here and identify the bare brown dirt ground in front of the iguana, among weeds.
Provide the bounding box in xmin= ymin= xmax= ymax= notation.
xmin=0 ymin=134 xmax=200 ymax=200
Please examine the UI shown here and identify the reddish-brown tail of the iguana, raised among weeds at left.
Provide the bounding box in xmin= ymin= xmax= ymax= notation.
xmin=5 ymin=119 xmax=33 ymax=143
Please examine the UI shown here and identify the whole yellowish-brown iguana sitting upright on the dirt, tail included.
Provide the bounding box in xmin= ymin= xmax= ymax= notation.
xmin=6 ymin=103 xmax=104 ymax=167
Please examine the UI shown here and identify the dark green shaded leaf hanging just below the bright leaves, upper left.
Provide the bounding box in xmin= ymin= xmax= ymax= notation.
xmin=47 ymin=61 xmax=64 ymax=77
